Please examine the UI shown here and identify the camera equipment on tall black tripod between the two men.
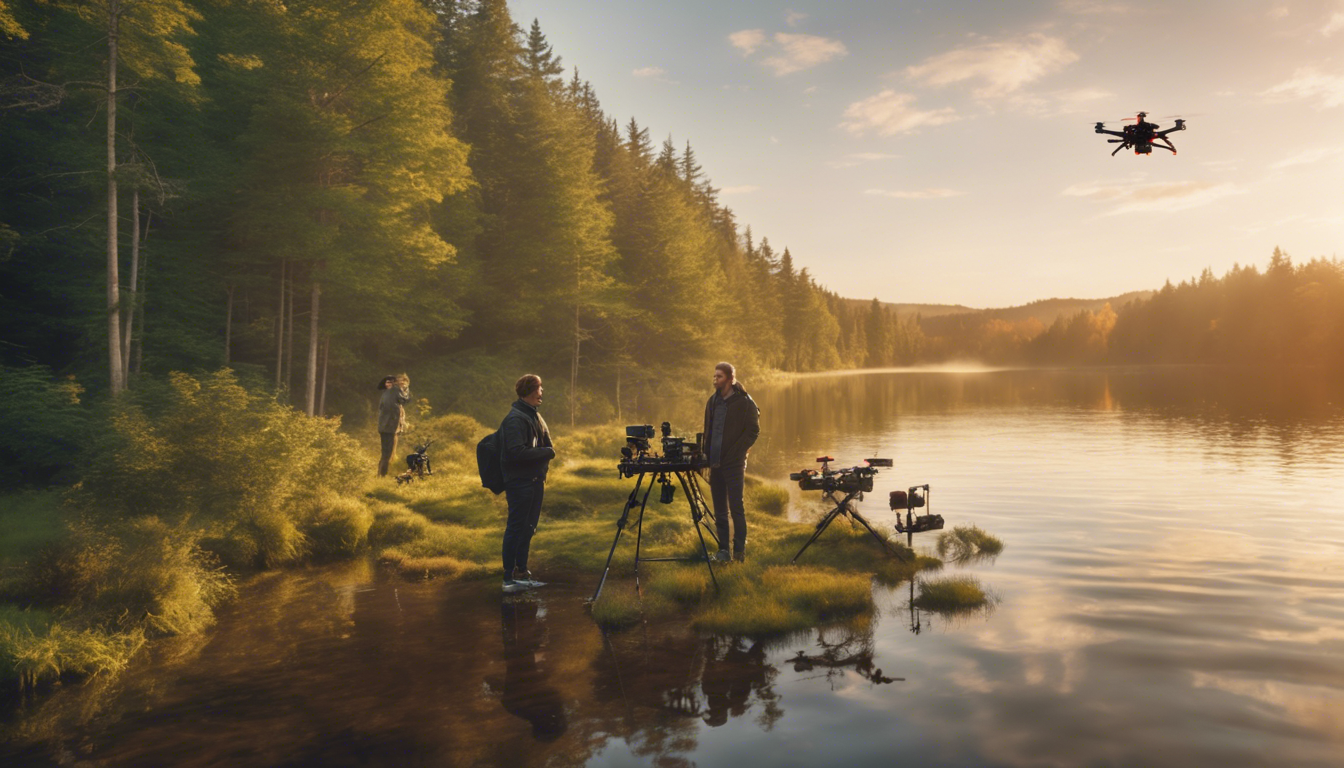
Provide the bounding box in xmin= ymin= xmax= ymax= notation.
xmin=589 ymin=421 xmax=719 ymax=603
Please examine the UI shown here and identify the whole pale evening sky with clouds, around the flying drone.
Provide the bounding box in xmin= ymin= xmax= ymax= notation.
xmin=509 ymin=0 xmax=1344 ymax=307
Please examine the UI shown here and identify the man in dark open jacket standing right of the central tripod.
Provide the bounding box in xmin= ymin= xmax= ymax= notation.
xmin=704 ymin=363 xmax=761 ymax=561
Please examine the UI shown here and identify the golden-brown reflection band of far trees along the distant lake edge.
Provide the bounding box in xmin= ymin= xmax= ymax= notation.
xmin=751 ymin=366 xmax=1341 ymax=475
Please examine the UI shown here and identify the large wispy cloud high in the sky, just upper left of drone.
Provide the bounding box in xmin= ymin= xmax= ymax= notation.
xmin=906 ymin=32 xmax=1078 ymax=98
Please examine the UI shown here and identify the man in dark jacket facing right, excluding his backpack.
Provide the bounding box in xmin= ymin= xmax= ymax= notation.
xmin=500 ymin=374 xmax=555 ymax=594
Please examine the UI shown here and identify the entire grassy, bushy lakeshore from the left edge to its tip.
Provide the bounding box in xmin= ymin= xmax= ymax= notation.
xmin=0 ymin=371 xmax=1001 ymax=694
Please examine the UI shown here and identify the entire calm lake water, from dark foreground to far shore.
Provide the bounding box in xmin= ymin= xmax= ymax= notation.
xmin=0 ymin=370 xmax=1344 ymax=767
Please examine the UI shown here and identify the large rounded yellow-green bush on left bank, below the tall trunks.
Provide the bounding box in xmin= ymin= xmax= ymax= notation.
xmin=77 ymin=369 xmax=370 ymax=566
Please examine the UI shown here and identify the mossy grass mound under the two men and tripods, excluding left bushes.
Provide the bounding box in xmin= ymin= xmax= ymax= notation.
xmin=368 ymin=417 xmax=941 ymax=633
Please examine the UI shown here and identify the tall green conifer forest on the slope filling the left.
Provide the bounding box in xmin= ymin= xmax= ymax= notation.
xmin=0 ymin=0 xmax=919 ymax=427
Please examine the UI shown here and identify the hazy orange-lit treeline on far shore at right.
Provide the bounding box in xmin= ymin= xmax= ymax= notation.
xmin=921 ymin=249 xmax=1344 ymax=373
